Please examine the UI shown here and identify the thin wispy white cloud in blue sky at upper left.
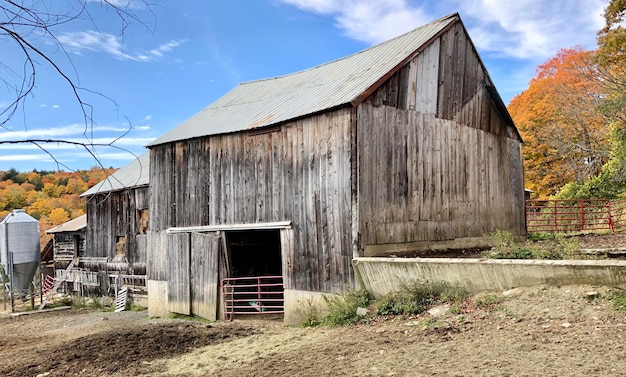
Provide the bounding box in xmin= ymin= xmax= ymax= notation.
xmin=57 ymin=30 xmax=186 ymax=61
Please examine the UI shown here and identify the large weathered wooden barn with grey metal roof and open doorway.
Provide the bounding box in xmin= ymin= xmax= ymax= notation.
xmin=147 ymin=14 xmax=525 ymax=322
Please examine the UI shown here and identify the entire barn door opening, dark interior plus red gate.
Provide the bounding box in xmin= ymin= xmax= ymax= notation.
xmin=222 ymin=229 xmax=284 ymax=319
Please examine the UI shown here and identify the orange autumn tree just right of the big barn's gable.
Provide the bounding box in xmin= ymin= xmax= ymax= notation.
xmin=508 ymin=47 xmax=610 ymax=198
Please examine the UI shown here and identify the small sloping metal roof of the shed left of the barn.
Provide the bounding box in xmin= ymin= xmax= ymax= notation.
xmin=80 ymin=152 xmax=150 ymax=197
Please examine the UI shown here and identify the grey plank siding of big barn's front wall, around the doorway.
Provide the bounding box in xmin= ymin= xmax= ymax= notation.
xmin=148 ymin=108 xmax=353 ymax=292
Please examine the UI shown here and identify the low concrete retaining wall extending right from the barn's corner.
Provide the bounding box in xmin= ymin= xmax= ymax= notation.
xmin=352 ymin=258 xmax=626 ymax=298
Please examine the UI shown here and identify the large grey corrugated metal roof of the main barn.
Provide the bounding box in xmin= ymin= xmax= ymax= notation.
xmin=148 ymin=13 xmax=459 ymax=146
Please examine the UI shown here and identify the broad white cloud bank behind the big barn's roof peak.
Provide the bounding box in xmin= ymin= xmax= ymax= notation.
xmin=279 ymin=0 xmax=606 ymax=59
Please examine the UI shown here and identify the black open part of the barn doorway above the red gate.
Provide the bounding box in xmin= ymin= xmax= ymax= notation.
xmin=226 ymin=230 xmax=282 ymax=277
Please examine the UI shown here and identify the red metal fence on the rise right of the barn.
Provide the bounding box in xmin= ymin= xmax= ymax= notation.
xmin=526 ymin=199 xmax=626 ymax=233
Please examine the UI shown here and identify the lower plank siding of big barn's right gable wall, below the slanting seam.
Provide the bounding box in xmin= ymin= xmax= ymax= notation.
xmin=358 ymin=104 xmax=524 ymax=245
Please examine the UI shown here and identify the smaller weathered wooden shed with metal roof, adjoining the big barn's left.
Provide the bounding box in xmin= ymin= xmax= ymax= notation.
xmin=77 ymin=152 xmax=150 ymax=294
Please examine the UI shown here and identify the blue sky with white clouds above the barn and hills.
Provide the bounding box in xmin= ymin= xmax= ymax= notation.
xmin=0 ymin=0 xmax=608 ymax=171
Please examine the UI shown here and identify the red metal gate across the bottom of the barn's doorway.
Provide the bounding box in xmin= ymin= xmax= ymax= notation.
xmin=222 ymin=276 xmax=285 ymax=320
